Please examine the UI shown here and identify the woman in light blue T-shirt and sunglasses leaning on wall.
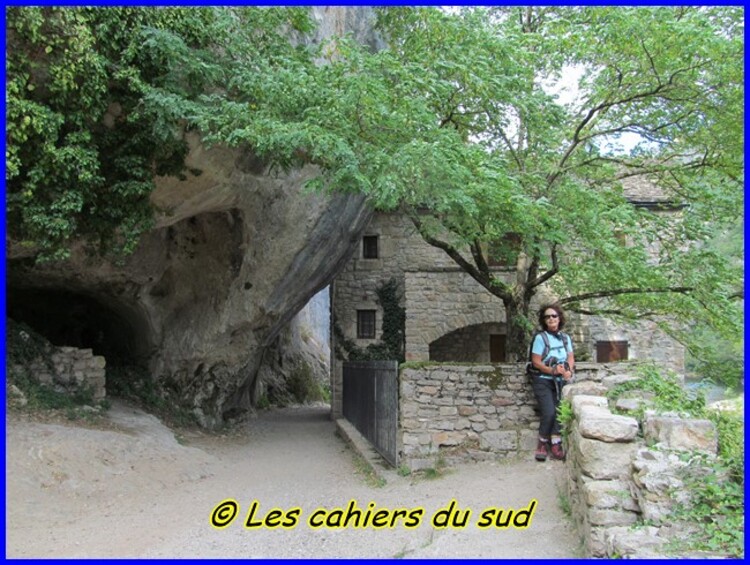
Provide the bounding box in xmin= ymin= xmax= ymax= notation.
xmin=531 ymin=304 xmax=575 ymax=461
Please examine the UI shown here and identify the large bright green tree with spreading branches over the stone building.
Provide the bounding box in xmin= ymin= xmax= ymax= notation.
xmin=9 ymin=7 xmax=744 ymax=378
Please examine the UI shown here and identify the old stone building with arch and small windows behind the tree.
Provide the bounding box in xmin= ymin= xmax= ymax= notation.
xmin=331 ymin=177 xmax=685 ymax=416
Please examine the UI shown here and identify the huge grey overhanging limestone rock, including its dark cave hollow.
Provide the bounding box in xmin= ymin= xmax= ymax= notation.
xmin=7 ymin=8 xmax=372 ymax=426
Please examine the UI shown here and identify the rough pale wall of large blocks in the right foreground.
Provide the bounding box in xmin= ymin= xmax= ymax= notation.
xmin=564 ymin=375 xmax=717 ymax=558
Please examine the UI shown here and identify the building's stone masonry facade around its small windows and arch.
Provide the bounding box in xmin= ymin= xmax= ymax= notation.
xmin=333 ymin=210 xmax=685 ymax=366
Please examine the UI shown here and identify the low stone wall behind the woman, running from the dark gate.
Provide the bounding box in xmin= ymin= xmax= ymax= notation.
xmin=399 ymin=363 xmax=627 ymax=470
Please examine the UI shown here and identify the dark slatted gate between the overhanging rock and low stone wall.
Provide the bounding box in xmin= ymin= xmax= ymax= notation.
xmin=342 ymin=361 xmax=398 ymax=467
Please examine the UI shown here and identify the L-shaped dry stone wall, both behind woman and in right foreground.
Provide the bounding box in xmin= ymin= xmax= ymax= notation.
xmin=399 ymin=363 xmax=718 ymax=558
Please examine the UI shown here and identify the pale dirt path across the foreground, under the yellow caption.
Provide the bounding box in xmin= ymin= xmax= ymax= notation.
xmin=6 ymin=403 xmax=579 ymax=558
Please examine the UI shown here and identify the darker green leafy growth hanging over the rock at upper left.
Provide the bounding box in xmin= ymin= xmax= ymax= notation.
xmin=6 ymin=7 xmax=311 ymax=260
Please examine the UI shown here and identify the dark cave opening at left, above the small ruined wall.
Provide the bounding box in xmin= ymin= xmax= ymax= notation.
xmin=6 ymin=287 xmax=150 ymax=366
